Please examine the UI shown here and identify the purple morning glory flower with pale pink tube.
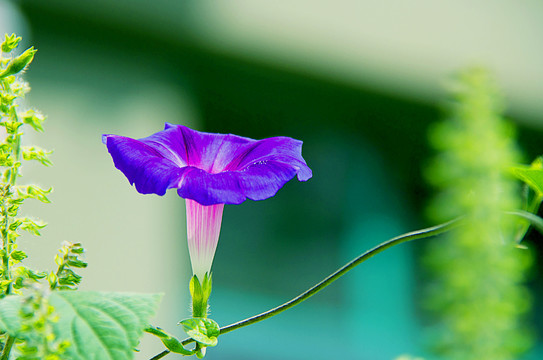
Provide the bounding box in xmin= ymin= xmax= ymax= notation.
xmin=102 ymin=123 xmax=312 ymax=281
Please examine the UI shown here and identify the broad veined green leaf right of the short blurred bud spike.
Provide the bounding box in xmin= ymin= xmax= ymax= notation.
xmin=49 ymin=291 xmax=161 ymax=360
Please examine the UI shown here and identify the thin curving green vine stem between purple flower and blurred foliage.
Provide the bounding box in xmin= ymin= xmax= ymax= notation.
xmin=150 ymin=218 xmax=461 ymax=360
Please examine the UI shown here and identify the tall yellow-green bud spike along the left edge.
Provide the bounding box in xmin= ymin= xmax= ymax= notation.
xmin=0 ymin=34 xmax=52 ymax=297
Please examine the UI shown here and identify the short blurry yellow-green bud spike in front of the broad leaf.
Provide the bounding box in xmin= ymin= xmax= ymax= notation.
xmin=17 ymin=292 xmax=70 ymax=360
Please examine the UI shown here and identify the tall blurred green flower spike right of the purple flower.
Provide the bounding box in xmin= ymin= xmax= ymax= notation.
xmin=427 ymin=68 xmax=533 ymax=360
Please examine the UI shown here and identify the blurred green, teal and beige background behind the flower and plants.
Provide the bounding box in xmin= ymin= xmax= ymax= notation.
xmin=0 ymin=0 xmax=543 ymax=360
